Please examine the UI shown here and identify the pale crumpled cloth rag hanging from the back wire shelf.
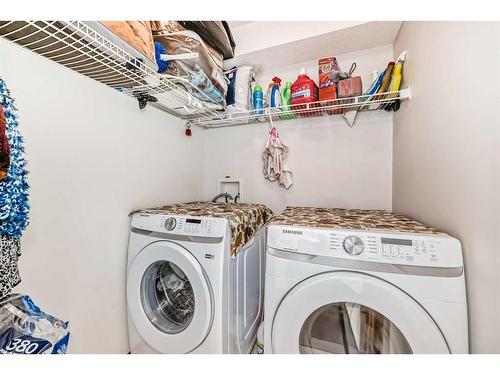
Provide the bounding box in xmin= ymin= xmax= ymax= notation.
xmin=262 ymin=116 xmax=293 ymax=189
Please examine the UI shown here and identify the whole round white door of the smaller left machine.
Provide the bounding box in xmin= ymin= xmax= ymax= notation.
xmin=127 ymin=241 xmax=213 ymax=353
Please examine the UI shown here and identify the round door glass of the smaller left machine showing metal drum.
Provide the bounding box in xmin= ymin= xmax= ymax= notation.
xmin=141 ymin=261 xmax=195 ymax=334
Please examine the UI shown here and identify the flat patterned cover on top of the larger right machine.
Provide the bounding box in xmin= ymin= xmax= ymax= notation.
xmin=269 ymin=207 xmax=441 ymax=234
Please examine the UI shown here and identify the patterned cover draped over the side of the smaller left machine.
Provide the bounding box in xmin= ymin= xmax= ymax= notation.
xmin=131 ymin=202 xmax=274 ymax=255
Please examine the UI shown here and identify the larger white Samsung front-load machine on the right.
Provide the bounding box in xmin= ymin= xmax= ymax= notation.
xmin=264 ymin=214 xmax=468 ymax=353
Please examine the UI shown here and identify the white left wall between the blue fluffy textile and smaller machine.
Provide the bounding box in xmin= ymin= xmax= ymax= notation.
xmin=0 ymin=41 xmax=201 ymax=353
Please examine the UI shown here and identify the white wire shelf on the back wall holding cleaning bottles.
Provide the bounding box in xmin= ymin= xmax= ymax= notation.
xmin=187 ymin=87 xmax=411 ymax=128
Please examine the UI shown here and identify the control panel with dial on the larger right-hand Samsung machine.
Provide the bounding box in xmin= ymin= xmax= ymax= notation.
xmin=267 ymin=225 xmax=463 ymax=267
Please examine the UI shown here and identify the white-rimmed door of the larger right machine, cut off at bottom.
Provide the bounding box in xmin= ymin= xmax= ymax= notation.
xmin=272 ymin=271 xmax=450 ymax=354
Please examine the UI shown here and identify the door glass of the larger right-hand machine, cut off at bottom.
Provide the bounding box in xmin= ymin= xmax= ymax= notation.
xmin=299 ymin=302 xmax=412 ymax=354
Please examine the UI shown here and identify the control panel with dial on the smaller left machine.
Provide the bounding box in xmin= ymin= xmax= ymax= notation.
xmin=131 ymin=213 xmax=228 ymax=237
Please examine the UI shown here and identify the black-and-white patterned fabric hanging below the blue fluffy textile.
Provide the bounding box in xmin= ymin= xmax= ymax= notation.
xmin=0 ymin=235 xmax=21 ymax=300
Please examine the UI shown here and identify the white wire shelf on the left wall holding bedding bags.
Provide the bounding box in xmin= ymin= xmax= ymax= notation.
xmin=0 ymin=21 xmax=223 ymax=119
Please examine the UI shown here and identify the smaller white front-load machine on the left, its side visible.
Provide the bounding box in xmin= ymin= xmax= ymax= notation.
xmin=127 ymin=213 xmax=266 ymax=353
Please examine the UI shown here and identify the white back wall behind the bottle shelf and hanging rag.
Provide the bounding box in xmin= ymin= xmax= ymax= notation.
xmin=203 ymin=45 xmax=393 ymax=212
